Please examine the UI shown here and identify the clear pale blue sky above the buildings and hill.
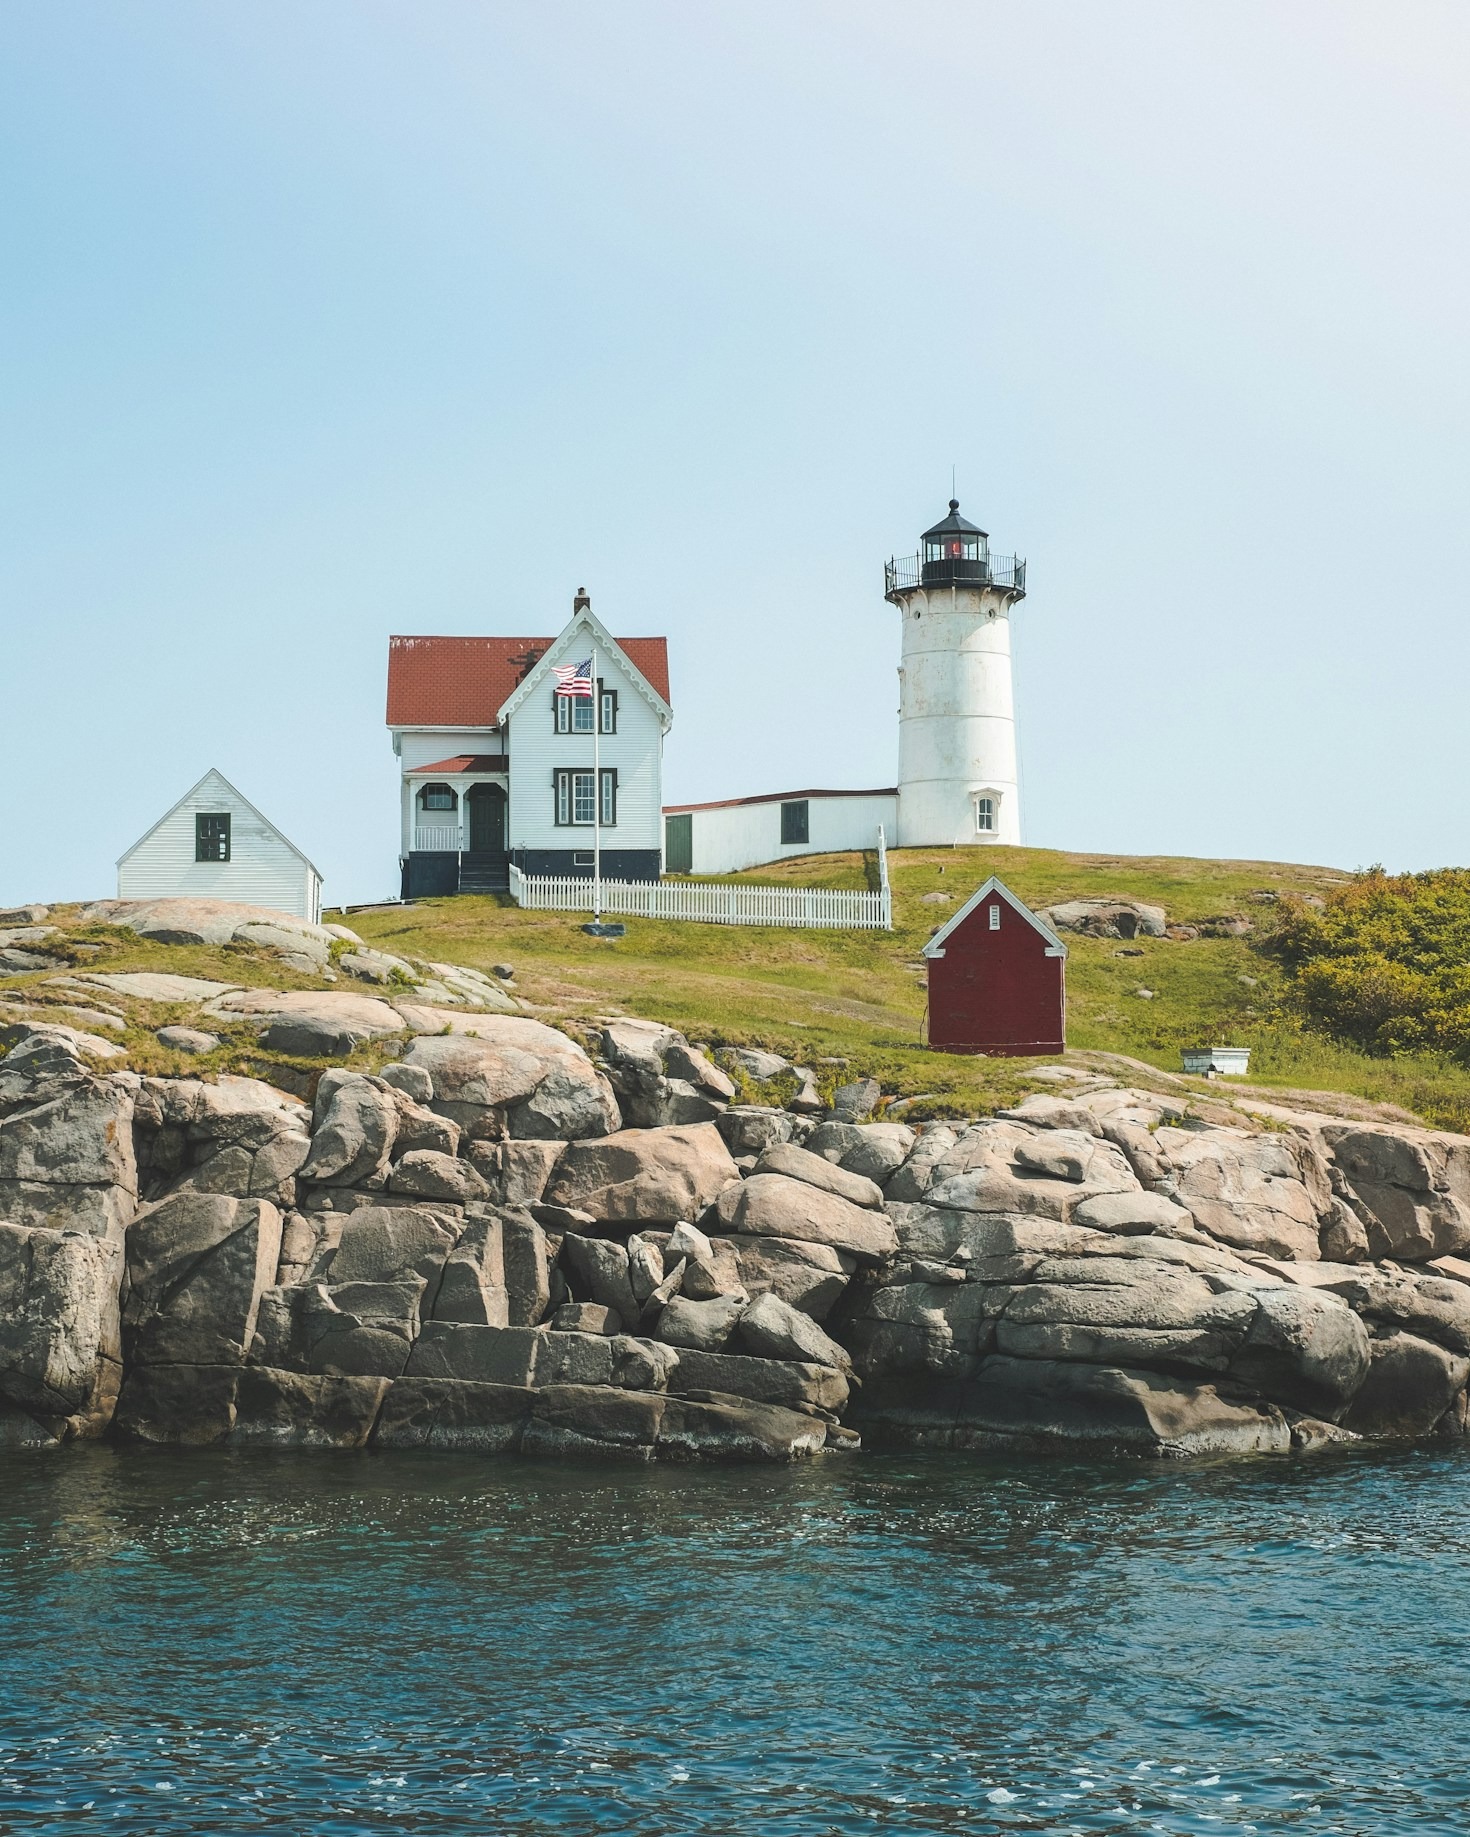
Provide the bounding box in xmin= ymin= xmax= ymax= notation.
xmin=0 ymin=0 xmax=1470 ymax=902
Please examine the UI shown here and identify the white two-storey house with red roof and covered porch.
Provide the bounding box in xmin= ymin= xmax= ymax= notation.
xmin=388 ymin=590 xmax=673 ymax=898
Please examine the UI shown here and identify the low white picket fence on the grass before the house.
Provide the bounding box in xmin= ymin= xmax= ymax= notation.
xmin=511 ymin=830 xmax=893 ymax=931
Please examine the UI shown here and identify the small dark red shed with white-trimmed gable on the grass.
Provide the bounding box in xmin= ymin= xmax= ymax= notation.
xmin=924 ymin=874 xmax=1068 ymax=1056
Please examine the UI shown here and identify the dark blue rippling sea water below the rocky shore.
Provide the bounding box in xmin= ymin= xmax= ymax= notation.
xmin=0 ymin=1448 xmax=1470 ymax=1837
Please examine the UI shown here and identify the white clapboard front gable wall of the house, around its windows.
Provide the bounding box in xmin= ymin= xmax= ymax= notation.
xmin=505 ymin=628 xmax=663 ymax=851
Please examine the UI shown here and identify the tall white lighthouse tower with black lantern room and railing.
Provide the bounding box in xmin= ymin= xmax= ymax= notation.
xmin=884 ymin=498 xmax=1025 ymax=849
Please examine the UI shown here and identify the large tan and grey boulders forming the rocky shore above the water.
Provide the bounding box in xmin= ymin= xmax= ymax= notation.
xmin=0 ymin=900 xmax=1470 ymax=1460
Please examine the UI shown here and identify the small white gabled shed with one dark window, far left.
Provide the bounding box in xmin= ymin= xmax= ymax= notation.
xmin=118 ymin=766 xmax=322 ymax=924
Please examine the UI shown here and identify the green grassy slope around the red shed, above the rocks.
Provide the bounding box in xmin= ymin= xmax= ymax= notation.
xmin=341 ymin=849 xmax=1470 ymax=1128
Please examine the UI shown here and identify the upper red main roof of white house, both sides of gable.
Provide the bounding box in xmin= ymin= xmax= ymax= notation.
xmin=388 ymin=637 xmax=669 ymax=727
